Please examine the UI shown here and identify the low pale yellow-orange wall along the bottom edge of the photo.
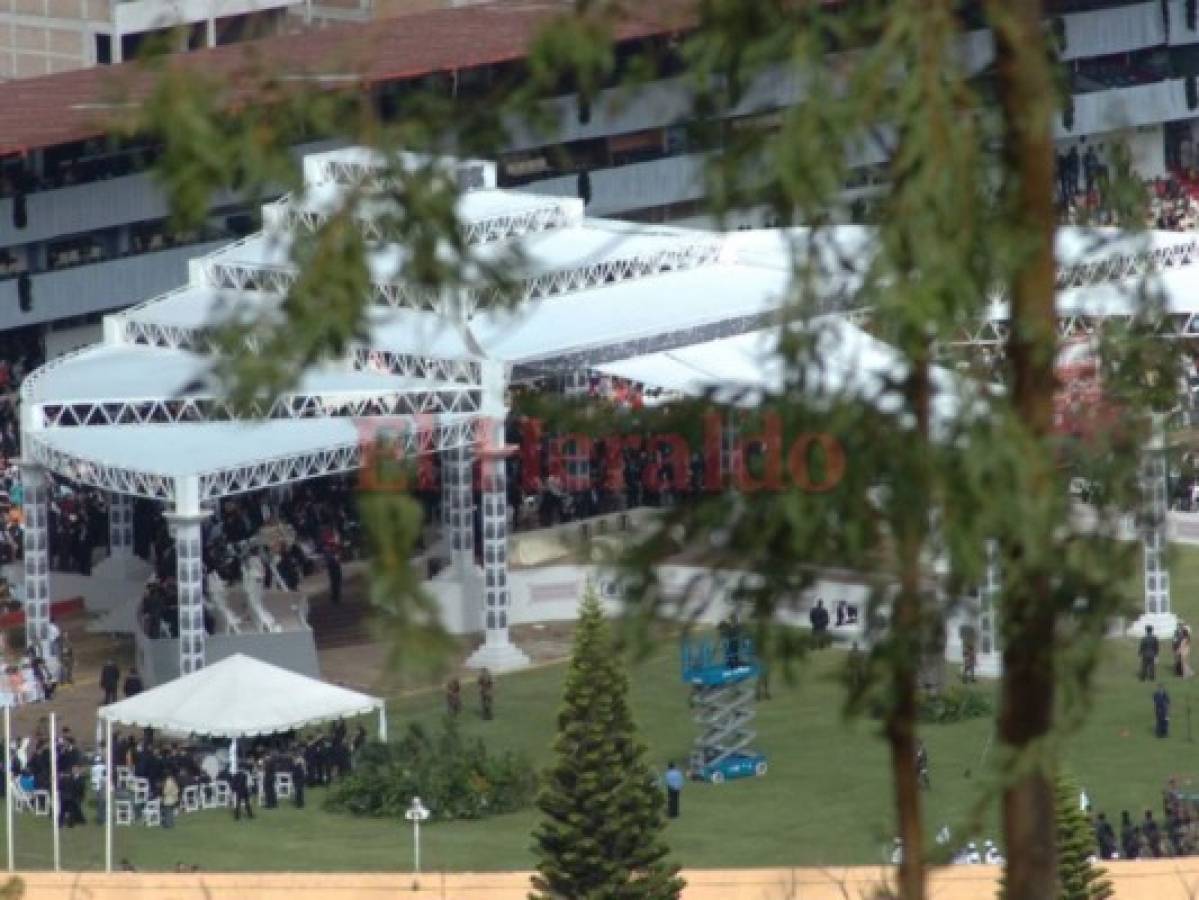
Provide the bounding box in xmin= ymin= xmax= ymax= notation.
xmin=7 ymin=858 xmax=1199 ymax=900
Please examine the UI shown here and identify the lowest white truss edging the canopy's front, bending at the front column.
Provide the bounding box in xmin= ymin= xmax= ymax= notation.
xmin=23 ymin=416 xmax=478 ymax=502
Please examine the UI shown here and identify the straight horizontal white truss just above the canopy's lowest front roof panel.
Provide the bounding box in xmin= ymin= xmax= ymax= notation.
xmin=29 ymin=387 xmax=482 ymax=428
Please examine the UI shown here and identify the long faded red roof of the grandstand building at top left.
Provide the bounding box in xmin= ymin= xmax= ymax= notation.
xmin=0 ymin=0 xmax=694 ymax=156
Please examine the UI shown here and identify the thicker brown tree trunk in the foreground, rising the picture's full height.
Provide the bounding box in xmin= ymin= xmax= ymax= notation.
xmin=987 ymin=0 xmax=1056 ymax=900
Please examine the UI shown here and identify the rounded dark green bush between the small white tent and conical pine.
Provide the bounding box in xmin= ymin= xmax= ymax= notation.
xmin=325 ymin=719 xmax=537 ymax=820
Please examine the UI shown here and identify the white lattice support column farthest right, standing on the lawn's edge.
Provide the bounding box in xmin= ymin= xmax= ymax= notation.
xmin=1129 ymin=417 xmax=1177 ymax=639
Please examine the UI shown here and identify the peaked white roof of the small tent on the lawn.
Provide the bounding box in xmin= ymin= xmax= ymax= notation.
xmin=97 ymin=653 xmax=384 ymax=738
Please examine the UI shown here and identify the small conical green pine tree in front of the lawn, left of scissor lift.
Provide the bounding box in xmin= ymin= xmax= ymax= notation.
xmin=531 ymin=586 xmax=683 ymax=900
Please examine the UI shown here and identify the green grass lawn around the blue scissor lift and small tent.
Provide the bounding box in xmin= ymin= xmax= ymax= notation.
xmin=7 ymin=541 xmax=1199 ymax=870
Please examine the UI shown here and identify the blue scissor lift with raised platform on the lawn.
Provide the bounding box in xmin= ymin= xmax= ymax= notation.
xmin=682 ymin=638 xmax=766 ymax=784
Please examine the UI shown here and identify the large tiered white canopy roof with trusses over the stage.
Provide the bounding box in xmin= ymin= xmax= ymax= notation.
xmin=22 ymin=144 xmax=1179 ymax=503
